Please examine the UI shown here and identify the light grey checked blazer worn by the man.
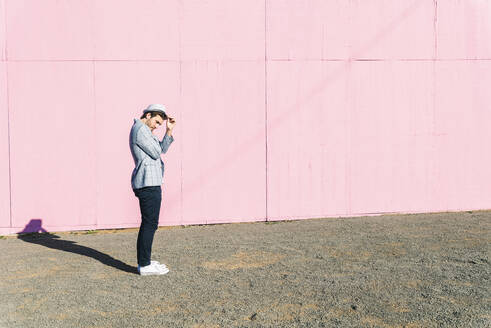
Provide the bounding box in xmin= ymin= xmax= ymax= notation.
xmin=130 ymin=118 xmax=174 ymax=189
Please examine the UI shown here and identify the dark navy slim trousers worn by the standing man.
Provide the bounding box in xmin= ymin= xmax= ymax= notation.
xmin=133 ymin=186 xmax=162 ymax=266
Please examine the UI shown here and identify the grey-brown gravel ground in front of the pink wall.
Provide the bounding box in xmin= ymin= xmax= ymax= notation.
xmin=0 ymin=211 xmax=491 ymax=328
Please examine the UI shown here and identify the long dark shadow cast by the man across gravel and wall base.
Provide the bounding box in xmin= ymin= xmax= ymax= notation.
xmin=17 ymin=219 xmax=138 ymax=274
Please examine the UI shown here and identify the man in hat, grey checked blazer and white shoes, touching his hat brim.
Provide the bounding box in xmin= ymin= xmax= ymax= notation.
xmin=130 ymin=104 xmax=176 ymax=275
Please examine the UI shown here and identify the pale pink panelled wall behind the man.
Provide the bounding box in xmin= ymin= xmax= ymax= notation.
xmin=0 ymin=0 xmax=491 ymax=234
